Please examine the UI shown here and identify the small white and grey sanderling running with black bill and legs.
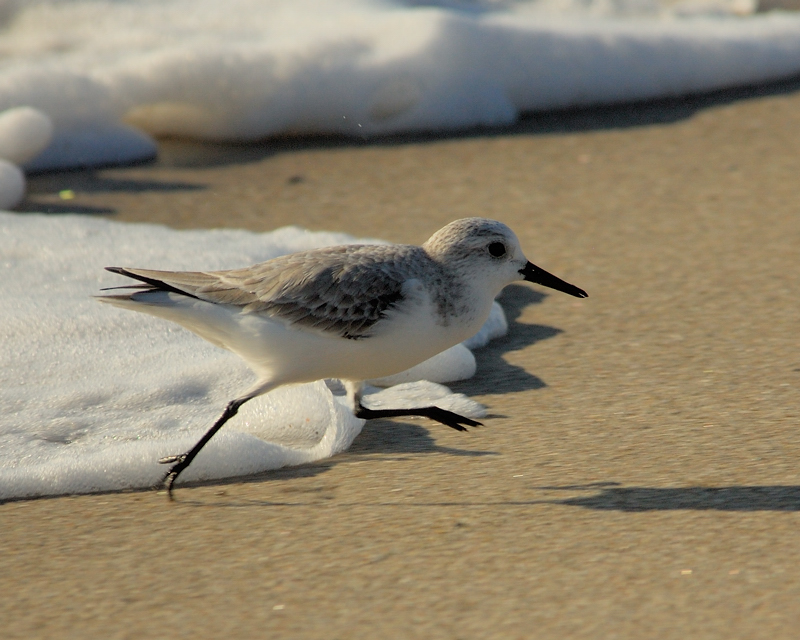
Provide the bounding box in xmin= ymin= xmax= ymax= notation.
xmin=100 ymin=218 xmax=587 ymax=498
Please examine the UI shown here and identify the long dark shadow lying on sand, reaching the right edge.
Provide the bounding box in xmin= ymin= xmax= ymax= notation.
xmin=535 ymin=482 xmax=800 ymax=512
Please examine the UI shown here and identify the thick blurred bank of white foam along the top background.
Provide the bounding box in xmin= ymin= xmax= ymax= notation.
xmin=0 ymin=0 xmax=800 ymax=178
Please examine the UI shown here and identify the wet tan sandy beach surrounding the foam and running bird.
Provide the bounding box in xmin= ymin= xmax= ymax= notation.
xmin=6 ymin=82 xmax=800 ymax=639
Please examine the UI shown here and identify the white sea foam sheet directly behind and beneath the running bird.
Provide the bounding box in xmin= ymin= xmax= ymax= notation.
xmin=0 ymin=213 xmax=505 ymax=498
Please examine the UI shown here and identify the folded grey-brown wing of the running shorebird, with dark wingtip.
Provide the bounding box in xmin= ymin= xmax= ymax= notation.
xmin=109 ymin=245 xmax=429 ymax=339
